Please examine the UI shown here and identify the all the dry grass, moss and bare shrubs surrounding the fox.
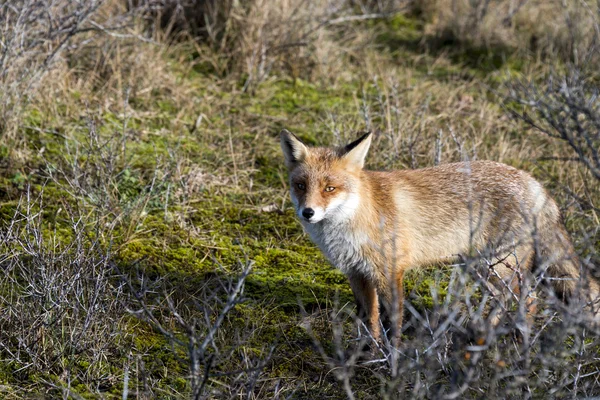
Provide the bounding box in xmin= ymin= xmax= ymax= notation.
xmin=0 ymin=0 xmax=600 ymax=399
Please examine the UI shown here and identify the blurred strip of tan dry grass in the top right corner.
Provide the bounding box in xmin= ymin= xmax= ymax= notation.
xmin=419 ymin=0 xmax=600 ymax=66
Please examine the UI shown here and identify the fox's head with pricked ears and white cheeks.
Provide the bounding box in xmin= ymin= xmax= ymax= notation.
xmin=280 ymin=129 xmax=371 ymax=224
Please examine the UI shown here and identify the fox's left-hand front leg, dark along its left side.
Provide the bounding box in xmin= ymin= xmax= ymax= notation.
xmin=348 ymin=275 xmax=381 ymax=341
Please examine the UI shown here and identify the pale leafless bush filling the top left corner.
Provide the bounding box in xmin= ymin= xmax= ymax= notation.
xmin=0 ymin=0 xmax=142 ymax=136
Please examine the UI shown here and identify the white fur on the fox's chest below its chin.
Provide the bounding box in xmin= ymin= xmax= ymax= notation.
xmin=303 ymin=220 xmax=374 ymax=276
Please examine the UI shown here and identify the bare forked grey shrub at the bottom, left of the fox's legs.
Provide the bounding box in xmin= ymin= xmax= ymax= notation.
xmin=127 ymin=262 xmax=282 ymax=399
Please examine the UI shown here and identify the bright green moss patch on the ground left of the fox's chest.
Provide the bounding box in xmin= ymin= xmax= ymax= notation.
xmin=118 ymin=199 xmax=351 ymax=309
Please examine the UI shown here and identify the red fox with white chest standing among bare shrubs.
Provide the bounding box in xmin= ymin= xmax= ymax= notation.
xmin=280 ymin=130 xmax=600 ymax=340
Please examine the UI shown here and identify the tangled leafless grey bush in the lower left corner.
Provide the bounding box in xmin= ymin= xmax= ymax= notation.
xmin=0 ymin=190 xmax=124 ymax=396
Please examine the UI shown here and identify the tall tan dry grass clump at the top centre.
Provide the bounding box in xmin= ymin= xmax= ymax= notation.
xmin=141 ymin=0 xmax=404 ymax=90
